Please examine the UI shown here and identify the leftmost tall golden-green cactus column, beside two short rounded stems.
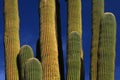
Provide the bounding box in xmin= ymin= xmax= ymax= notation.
xmin=4 ymin=0 xmax=20 ymax=80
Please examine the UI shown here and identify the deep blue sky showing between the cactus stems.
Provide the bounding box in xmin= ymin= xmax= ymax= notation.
xmin=0 ymin=0 xmax=120 ymax=80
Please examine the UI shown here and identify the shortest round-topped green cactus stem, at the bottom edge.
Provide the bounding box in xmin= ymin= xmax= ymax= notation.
xmin=24 ymin=58 xmax=42 ymax=80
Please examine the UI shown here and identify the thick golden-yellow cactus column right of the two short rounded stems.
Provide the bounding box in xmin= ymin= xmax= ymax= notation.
xmin=40 ymin=0 xmax=60 ymax=80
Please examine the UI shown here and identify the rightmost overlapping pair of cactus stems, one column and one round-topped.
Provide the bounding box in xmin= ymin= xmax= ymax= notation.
xmin=90 ymin=0 xmax=116 ymax=80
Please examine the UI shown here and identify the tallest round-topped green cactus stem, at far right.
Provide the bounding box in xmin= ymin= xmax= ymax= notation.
xmin=97 ymin=13 xmax=116 ymax=80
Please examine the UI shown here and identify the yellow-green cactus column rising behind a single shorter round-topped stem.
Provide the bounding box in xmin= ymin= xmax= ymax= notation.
xmin=67 ymin=0 xmax=84 ymax=80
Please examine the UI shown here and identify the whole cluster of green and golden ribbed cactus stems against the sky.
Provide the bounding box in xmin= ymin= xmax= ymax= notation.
xmin=4 ymin=0 xmax=116 ymax=80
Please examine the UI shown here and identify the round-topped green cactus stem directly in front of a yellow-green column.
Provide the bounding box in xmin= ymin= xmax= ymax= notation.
xmin=67 ymin=31 xmax=81 ymax=80
